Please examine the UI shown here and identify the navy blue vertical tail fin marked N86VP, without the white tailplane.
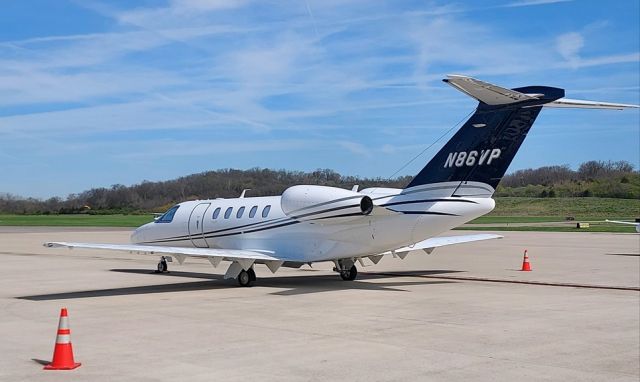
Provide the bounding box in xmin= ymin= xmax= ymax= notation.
xmin=407 ymin=86 xmax=564 ymax=189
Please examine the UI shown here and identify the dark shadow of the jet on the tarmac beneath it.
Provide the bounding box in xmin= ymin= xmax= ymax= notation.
xmin=16 ymin=269 xmax=459 ymax=301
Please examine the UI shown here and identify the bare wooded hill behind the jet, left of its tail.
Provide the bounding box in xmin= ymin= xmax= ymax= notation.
xmin=0 ymin=168 xmax=411 ymax=214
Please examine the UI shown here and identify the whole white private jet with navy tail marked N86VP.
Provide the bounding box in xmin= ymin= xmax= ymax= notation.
xmin=45 ymin=75 xmax=637 ymax=286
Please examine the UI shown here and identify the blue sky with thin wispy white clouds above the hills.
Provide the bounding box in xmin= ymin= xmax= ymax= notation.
xmin=0 ymin=0 xmax=640 ymax=198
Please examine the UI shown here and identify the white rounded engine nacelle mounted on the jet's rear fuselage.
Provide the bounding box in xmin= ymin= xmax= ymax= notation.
xmin=280 ymin=185 xmax=373 ymax=224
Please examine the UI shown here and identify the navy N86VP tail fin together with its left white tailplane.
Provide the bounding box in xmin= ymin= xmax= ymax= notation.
xmin=407 ymin=76 xmax=564 ymax=196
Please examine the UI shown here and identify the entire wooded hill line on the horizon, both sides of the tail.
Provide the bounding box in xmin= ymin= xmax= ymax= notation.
xmin=0 ymin=161 xmax=640 ymax=214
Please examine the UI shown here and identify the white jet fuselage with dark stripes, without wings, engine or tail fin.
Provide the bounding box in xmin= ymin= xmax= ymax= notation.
xmin=131 ymin=182 xmax=495 ymax=263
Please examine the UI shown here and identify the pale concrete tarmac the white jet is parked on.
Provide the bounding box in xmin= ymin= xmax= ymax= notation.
xmin=0 ymin=227 xmax=640 ymax=382
